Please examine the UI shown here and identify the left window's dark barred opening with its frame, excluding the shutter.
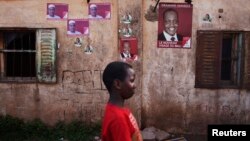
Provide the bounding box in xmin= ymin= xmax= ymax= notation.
xmin=0 ymin=30 xmax=36 ymax=81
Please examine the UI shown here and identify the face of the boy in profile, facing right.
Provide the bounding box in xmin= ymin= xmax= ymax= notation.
xmin=121 ymin=68 xmax=136 ymax=99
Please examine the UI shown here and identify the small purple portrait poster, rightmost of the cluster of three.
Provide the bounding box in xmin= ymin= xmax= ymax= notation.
xmin=89 ymin=3 xmax=111 ymax=20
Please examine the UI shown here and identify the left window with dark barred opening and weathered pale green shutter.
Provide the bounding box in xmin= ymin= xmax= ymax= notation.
xmin=0 ymin=29 xmax=56 ymax=82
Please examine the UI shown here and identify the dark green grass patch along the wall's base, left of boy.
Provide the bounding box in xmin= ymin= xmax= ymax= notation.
xmin=0 ymin=116 xmax=101 ymax=141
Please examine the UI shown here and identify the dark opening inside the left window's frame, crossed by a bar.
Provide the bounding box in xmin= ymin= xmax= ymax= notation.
xmin=4 ymin=31 xmax=36 ymax=77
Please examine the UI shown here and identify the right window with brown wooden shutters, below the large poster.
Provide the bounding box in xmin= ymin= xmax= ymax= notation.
xmin=195 ymin=31 xmax=250 ymax=88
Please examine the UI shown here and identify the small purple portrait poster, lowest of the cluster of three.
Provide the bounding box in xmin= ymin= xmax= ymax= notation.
xmin=67 ymin=19 xmax=89 ymax=36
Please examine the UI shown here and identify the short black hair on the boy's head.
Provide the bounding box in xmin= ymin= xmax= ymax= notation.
xmin=102 ymin=61 xmax=132 ymax=92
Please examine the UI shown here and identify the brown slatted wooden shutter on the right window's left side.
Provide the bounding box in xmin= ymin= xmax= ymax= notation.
xmin=195 ymin=31 xmax=222 ymax=88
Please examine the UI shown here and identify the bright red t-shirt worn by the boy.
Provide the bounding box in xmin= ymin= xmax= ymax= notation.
xmin=102 ymin=103 xmax=142 ymax=141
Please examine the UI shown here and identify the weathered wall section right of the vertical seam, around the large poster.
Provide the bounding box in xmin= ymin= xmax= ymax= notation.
xmin=142 ymin=0 xmax=250 ymax=133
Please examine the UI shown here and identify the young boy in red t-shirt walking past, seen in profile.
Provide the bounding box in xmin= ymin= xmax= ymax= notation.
xmin=102 ymin=62 xmax=142 ymax=141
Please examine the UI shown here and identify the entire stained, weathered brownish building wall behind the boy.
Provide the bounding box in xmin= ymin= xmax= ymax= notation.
xmin=0 ymin=0 xmax=250 ymax=133
